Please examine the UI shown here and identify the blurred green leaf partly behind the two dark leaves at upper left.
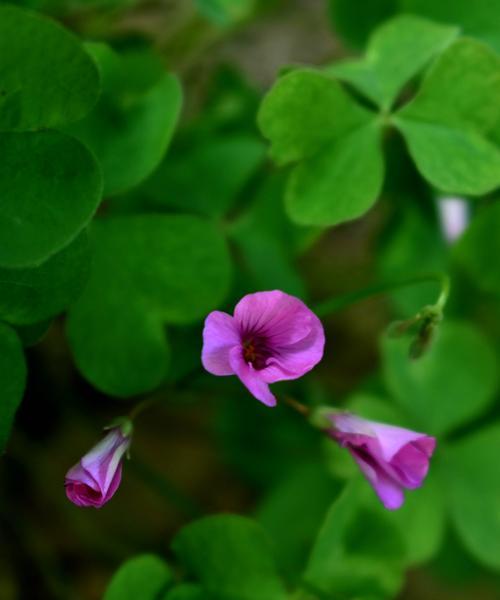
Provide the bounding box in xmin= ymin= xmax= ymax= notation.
xmin=69 ymin=44 xmax=182 ymax=195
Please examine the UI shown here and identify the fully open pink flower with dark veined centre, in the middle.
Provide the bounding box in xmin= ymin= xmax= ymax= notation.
xmin=201 ymin=290 xmax=325 ymax=406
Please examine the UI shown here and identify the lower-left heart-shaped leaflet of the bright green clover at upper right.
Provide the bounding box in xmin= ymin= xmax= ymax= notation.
xmin=259 ymin=69 xmax=384 ymax=225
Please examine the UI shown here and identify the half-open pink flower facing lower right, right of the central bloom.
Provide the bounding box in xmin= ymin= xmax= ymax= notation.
xmin=328 ymin=413 xmax=436 ymax=510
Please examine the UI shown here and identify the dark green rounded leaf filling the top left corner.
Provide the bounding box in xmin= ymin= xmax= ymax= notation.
xmin=0 ymin=5 xmax=99 ymax=130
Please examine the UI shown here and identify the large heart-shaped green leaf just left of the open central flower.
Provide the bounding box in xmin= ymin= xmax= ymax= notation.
xmin=68 ymin=215 xmax=230 ymax=397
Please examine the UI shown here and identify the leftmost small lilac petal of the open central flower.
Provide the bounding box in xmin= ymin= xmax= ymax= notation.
xmin=201 ymin=311 xmax=241 ymax=375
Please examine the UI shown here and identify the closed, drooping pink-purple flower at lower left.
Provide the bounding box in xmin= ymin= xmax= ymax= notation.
xmin=64 ymin=427 xmax=130 ymax=508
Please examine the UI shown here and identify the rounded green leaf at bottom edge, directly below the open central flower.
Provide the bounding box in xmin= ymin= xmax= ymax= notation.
xmin=173 ymin=515 xmax=286 ymax=600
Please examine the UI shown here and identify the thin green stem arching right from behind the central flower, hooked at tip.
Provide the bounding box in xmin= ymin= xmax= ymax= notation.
xmin=314 ymin=273 xmax=450 ymax=317
